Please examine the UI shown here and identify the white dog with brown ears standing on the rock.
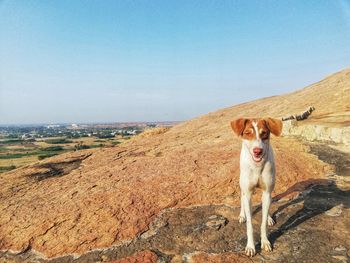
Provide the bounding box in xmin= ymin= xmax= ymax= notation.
xmin=231 ymin=118 xmax=283 ymax=257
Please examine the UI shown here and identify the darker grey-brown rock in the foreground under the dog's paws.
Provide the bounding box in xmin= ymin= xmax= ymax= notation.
xmin=0 ymin=170 xmax=350 ymax=263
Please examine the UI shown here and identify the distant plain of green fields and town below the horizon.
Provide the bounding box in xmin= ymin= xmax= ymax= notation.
xmin=0 ymin=122 xmax=178 ymax=172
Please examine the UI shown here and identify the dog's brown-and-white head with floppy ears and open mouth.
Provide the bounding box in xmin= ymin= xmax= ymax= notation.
xmin=231 ymin=118 xmax=282 ymax=163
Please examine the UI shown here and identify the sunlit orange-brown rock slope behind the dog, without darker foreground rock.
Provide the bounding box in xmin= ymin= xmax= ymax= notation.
xmin=0 ymin=69 xmax=350 ymax=262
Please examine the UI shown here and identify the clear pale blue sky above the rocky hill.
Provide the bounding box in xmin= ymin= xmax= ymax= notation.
xmin=0 ymin=0 xmax=350 ymax=124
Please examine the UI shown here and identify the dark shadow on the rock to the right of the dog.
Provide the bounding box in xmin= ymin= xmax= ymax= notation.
xmin=253 ymin=179 xmax=350 ymax=250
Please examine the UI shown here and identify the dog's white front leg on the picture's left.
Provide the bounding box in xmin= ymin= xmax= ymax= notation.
xmin=243 ymin=190 xmax=255 ymax=257
